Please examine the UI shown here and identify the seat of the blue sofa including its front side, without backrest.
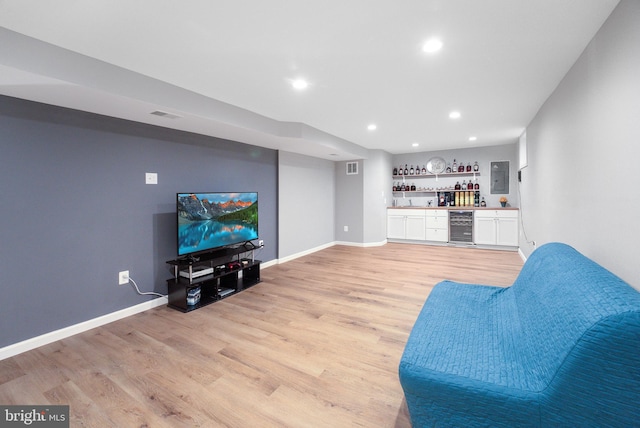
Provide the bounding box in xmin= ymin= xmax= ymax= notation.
xmin=400 ymin=281 xmax=540 ymax=427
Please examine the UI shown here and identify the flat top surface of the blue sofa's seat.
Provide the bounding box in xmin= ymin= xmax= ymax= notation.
xmin=403 ymin=281 xmax=542 ymax=391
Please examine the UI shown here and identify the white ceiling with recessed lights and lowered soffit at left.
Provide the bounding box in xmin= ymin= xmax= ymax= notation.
xmin=0 ymin=0 xmax=618 ymax=160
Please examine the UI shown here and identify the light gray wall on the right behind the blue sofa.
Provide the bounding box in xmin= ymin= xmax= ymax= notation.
xmin=520 ymin=0 xmax=640 ymax=289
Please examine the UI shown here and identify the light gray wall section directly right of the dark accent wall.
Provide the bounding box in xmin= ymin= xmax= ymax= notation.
xmin=278 ymin=152 xmax=336 ymax=259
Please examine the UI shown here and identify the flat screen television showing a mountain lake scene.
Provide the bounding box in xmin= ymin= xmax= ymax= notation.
xmin=177 ymin=192 xmax=258 ymax=256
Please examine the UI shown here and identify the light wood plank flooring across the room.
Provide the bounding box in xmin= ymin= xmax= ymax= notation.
xmin=0 ymin=243 xmax=522 ymax=428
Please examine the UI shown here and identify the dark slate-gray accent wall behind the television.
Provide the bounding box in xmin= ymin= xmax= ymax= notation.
xmin=0 ymin=96 xmax=278 ymax=347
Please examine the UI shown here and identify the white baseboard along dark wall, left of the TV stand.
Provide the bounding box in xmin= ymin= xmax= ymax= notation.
xmin=0 ymin=297 xmax=167 ymax=361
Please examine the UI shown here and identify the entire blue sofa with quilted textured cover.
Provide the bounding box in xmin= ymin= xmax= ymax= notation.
xmin=400 ymin=243 xmax=640 ymax=427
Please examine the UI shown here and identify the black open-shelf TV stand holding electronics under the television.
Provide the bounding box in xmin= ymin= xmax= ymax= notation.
xmin=167 ymin=245 xmax=261 ymax=312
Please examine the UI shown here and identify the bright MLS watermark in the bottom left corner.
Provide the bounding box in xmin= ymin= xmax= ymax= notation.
xmin=0 ymin=405 xmax=69 ymax=428
